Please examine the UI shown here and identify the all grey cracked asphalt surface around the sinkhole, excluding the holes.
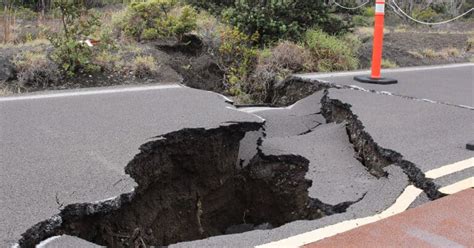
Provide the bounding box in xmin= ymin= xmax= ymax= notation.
xmin=0 ymin=64 xmax=474 ymax=247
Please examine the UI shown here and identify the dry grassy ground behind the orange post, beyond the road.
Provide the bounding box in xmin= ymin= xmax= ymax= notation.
xmin=356 ymin=21 xmax=474 ymax=68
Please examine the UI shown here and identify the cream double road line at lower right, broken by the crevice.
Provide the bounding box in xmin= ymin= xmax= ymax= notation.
xmin=255 ymin=158 xmax=474 ymax=248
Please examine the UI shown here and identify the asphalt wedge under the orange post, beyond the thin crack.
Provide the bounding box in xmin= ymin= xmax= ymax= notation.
xmin=299 ymin=63 xmax=474 ymax=107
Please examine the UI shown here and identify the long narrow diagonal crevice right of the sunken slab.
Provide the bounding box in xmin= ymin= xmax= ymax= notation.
xmin=321 ymin=90 xmax=444 ymax=200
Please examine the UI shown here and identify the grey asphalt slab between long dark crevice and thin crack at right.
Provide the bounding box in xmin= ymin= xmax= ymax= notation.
xmin=327 ymin=89 xmax=474 ymax=175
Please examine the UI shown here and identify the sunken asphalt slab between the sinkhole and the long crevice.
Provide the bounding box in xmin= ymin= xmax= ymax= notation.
xmin=262 ymin=123 xmax=378 ymax=205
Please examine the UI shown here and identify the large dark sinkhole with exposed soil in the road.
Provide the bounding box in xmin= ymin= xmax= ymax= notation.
xmin=19 ymin=122 xmax=330 ymax=247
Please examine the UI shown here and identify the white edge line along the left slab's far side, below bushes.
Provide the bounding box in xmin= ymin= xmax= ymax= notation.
xmin=0 ymin=84 xmax=184 ymax=102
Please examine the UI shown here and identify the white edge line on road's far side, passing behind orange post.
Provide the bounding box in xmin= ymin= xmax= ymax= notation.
xmin=294 ymin=63 xmax=474 ymax=79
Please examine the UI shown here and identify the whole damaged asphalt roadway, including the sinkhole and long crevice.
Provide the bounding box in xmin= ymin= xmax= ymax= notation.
xmin=0 ymin=65 xmax=474 ymax=247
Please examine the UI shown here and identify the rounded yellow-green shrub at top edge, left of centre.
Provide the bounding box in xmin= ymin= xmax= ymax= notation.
xmin=113 ymin=0 xmax=197 ymax=40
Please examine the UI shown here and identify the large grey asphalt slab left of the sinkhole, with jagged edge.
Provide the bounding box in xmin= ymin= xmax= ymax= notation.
xmin=0 ymin=87 xmax=263 ymax=248
